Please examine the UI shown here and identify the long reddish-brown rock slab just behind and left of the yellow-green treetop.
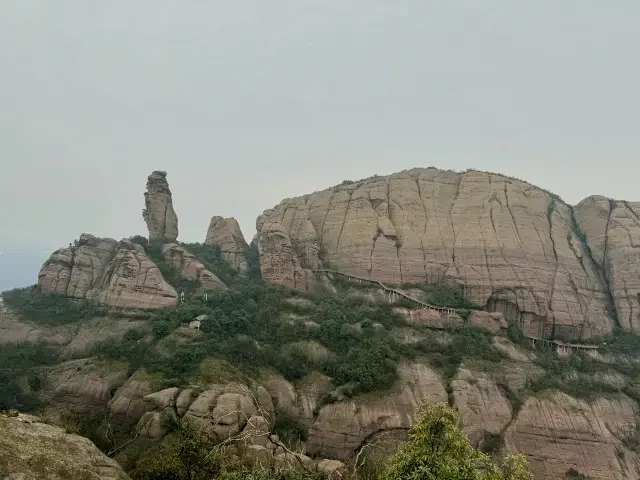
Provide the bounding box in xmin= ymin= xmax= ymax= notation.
xmin=306 ymin=363 xmax=447 ymax=460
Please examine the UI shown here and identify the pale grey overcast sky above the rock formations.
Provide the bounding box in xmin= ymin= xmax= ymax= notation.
xmin=0 ymin=0 xmax=640 ymax=290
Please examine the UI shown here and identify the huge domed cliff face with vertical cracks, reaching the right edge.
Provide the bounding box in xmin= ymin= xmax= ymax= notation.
xmin=256 ymin=168 xmax=640 ymax=338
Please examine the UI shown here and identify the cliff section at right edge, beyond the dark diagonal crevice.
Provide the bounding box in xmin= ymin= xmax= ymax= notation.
xmin=574 ymin=196 xmax=640 ymax=333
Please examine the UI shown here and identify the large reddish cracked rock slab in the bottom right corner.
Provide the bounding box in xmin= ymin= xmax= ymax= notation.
xmin=505 ymin=393 xmax=640 ymax=480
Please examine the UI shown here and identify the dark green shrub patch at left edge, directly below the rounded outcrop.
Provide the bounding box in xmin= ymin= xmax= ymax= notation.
xmin=0 ymin=285 xmax=106 ymax=325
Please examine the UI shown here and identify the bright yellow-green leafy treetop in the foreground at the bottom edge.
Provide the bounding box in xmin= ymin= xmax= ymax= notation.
xmin=382 ymin=403 xmax=533 ymax=480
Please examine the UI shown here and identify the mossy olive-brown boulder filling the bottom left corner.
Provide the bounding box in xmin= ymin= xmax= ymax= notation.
xmin=0 ymin=415 xmax=129 ymax=480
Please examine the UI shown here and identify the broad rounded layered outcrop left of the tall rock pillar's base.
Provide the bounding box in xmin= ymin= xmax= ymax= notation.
xmin=38 ymin=234 xmax=177 ymax=308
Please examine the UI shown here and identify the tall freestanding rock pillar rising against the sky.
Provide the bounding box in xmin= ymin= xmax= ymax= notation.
xmin=142 ymin=171 xmax=178 ymax=243
